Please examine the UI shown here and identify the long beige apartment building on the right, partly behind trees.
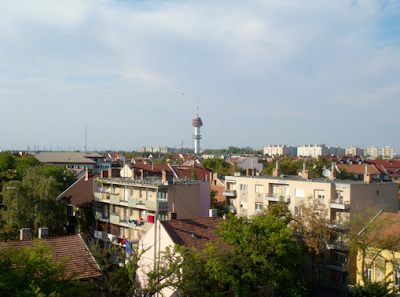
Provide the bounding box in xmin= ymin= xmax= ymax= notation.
xmin=223 ymin=169 xmax=399 ymax=289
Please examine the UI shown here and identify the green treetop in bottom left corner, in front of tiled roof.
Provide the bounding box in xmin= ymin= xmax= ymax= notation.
xmin=0 ymin=240 xmax=92 ymax=297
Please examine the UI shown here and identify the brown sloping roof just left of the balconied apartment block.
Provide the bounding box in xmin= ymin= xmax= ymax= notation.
xmin=57 ymin=175 xmax=99 ymax=206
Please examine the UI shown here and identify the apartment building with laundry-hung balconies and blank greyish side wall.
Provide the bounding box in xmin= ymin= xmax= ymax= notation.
xmin=94 ymin=172 xmax=211 ymax=246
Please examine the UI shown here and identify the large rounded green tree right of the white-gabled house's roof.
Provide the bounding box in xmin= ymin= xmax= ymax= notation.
xmin=205 ymin=214 xmax=305 ymax=296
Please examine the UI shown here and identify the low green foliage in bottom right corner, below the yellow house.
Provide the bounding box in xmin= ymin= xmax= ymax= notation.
xmin=347 ymin=278 xmax=399 ymax=297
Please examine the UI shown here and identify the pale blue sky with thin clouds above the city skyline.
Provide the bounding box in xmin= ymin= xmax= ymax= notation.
xmin=0 ymin=0 xmax=400 ymax=153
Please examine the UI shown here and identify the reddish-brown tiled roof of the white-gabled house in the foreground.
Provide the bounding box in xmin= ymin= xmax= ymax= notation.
xmin=161 ymin=217 xmax=226 ymax=252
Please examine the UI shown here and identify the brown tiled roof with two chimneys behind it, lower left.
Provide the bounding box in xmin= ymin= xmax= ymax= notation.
xmin=0 ymin=234 xmax=101 ymax=279
